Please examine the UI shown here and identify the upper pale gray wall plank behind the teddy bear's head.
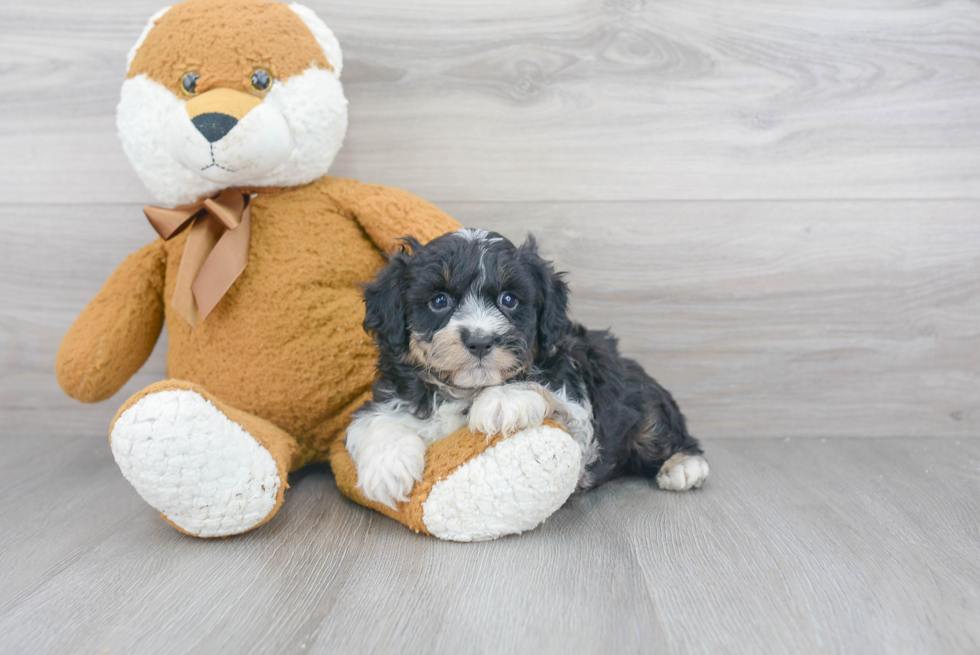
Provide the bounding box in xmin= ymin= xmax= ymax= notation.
xmin=0 ymin=0 xmax=980 ymax=203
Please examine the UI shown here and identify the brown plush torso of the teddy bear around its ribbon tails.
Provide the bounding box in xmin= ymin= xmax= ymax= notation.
xmin=157 ymin=188 xmax=385 ymax=454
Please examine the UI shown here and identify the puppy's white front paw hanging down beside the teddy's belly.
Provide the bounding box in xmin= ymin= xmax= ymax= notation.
xmin=345 ymin=407 xmax=426 ymax=509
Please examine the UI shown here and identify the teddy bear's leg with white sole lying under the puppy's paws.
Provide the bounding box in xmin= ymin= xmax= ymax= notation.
xmin=330 ymin=422 xmax=582 ymax=541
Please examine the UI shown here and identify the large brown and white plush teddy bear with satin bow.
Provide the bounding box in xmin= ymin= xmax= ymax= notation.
xmin=56 ymin=0 xmax=581 ymax=541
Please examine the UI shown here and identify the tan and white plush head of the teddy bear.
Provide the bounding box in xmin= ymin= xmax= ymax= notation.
xmin=116 ymin=0 xmax=347 ymax=206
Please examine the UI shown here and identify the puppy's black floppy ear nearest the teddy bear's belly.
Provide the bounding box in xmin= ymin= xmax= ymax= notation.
xmin=364 ymin=244 xmax=411 ymax=357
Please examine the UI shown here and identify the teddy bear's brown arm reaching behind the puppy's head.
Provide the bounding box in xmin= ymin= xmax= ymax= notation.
xmin=349 ymin=182 xmax=461 ymax=252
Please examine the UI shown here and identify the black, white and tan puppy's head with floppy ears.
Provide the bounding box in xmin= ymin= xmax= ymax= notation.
xmin=364 ymin=229 xmax=571 ymax=389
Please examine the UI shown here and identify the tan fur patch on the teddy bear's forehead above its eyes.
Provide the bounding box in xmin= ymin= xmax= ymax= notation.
xmin=128 ymin=0 xmax=334 ymax=96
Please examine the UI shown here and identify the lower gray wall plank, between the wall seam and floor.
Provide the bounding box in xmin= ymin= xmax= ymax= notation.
xmin=0 ymin=201 xmax=980 ymax=438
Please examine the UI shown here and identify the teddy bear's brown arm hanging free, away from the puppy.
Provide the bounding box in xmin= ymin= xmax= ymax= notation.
xmin=55 ymin=239 xmax=166 ymax=403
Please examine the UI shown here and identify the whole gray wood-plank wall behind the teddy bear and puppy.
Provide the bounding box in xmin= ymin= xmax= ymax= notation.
xmin=0 ymin=0 xmax=980 ymax=437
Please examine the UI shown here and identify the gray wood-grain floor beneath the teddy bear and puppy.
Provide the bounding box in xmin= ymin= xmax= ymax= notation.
xmin=0 ymin=437 xmax=980 ymax=654
